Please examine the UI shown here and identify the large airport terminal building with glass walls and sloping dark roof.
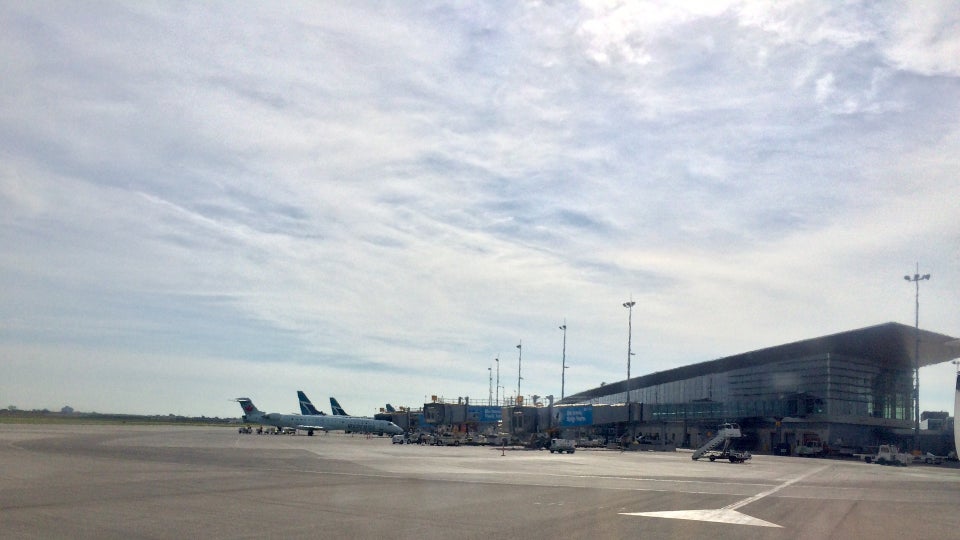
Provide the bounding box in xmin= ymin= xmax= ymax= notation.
xmin=556 ymin=323 xmax=960 ymax=452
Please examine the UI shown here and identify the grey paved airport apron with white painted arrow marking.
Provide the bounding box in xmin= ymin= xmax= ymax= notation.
xmin=0 ymin=425 xmax=960 ymax=540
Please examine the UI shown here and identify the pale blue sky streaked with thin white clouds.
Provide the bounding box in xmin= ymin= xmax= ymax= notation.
xmin=0 ymin=0 xmax=960 ymax=417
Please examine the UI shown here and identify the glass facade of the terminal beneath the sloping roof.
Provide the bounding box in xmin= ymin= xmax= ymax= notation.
xmin=590 ymin=353 xmax=913 ymax=422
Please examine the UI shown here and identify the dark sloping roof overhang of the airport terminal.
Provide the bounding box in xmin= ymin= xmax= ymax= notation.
xmin=561 ymin=322 xmax=960 ymax=403
